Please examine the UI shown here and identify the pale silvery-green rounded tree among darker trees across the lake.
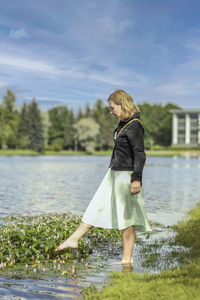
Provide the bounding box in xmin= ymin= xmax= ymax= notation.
xmin=74 ymin=117 xmax=99 ymax=153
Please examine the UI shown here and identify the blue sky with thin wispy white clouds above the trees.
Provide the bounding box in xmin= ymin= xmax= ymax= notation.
xmin=0 ymin=0 xmax=200 ymax=111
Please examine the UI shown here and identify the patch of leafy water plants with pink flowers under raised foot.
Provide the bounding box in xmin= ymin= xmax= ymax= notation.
xmin=0 ymin=214 xmax=121 ymax=278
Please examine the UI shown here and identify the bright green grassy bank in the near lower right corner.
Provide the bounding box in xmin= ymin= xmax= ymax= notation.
xmin=83 ymin=204 xmax=200 ymax=300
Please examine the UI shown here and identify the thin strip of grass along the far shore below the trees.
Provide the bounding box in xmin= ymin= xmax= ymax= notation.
xmin=0 ymin=148 xmax=200 ymax=157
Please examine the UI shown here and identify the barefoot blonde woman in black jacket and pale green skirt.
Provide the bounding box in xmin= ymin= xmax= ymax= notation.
xmin=55 ymin=90 xmax=151 ymax=265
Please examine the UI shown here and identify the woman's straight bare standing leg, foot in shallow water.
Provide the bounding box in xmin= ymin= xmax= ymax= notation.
xmin=121 ymin=226 xmax=135 ymax=264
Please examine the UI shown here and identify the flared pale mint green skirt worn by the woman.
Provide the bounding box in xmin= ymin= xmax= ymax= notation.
xmin=82 ymin=168 xmax=151 ymax=232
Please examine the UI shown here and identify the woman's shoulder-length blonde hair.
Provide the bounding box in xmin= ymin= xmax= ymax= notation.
xmin=108 ymin=90 xmax=139 ymax=120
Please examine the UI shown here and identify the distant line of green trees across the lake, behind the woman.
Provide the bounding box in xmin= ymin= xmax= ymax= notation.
xmin=0 ymin=90 xmax=178 ymax=153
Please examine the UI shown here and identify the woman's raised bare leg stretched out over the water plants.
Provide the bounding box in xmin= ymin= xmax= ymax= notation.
xmin=54 ymin=222 xmax=93 ymax=252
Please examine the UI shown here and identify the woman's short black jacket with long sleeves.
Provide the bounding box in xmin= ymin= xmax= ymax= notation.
xmin=109 ymin=112 xmax=146 ymax=182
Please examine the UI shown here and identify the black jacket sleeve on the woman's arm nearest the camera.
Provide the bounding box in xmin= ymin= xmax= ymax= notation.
xmin=126 ymin=121 xmax=146 ymax=183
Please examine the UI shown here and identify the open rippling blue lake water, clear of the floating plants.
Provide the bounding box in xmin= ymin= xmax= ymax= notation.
xmin=0 ymin=156 xmax=200 ymax=299
